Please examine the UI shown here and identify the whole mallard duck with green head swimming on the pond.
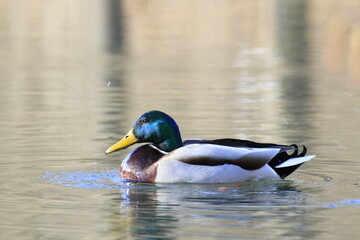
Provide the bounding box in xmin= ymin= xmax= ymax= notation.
xmin=105 ymin=111 xmax=315 ymax=183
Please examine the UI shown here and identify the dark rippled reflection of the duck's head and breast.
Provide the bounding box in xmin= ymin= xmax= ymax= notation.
xmin=111 ymin=186 xmax=179 ymax=239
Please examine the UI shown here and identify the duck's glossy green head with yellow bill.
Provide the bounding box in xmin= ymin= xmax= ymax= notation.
xmin=105 ymin=110 xmax=182 ymax=154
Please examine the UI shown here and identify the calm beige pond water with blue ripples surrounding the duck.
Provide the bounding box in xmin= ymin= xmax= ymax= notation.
xmin=0 ymin=0 xmax=360 ymax=239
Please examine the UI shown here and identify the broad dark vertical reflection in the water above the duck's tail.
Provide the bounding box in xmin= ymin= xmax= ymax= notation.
xmin=276 ymin=0 xmax=313 ymax=143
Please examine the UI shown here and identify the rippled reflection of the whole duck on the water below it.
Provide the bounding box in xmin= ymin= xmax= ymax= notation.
xmin=111 ymin=182 xmax=318 ymax=239
